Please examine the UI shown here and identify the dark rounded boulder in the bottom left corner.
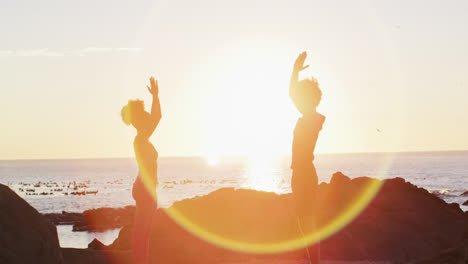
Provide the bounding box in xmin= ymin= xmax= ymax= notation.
xmin=0 ymin=184 xmax=63 ymax=264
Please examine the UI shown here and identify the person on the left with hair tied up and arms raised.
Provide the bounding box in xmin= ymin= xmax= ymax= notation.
xmin=121 ymin=77 xmax=161 ymax=264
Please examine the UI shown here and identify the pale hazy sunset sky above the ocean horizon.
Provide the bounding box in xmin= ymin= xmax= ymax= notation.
xmin=0 ymin=0 xmax=468 ymax=159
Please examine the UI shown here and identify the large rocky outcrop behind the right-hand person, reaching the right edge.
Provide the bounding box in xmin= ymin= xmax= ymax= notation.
xmin=102 ymin=173 xmax=468 ymax=263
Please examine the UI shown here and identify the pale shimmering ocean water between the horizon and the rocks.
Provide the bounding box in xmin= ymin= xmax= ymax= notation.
xmin=0 ymin=151 xmax=468 ymax=247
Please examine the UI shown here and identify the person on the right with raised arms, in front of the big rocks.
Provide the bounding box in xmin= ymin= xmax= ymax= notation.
xmin=289 ymin=52 xmax=325 ymax=264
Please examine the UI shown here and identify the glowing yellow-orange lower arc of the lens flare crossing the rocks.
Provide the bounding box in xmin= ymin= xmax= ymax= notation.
xmin=140 ymin=155 xmax=394 ymax=254
